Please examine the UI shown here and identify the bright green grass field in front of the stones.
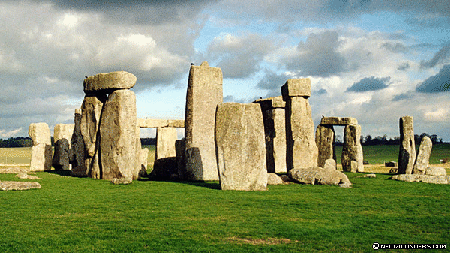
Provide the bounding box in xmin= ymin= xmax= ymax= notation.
xmin=0 ymin=144 xmax=450 ymax=252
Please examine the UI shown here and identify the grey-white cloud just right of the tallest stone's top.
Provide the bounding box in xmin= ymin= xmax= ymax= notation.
xmin=207 ymin=34 xmax=274 ymax=78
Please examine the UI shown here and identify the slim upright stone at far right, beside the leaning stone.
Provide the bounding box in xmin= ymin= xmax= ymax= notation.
xmin=398 ymin=116 xmax=416 ymax=174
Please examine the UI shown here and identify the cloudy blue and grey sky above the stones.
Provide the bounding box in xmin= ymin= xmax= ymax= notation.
xmin=0 ymin=0 xmax=450 ymax=142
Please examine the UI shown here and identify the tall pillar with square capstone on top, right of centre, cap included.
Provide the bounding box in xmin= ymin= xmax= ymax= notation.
xmin=281 ymin=78 xmax=318 ymax=171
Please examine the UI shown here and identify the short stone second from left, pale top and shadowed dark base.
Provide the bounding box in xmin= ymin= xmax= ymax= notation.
xmin=53 ymin=124 xmax=74 ymax=170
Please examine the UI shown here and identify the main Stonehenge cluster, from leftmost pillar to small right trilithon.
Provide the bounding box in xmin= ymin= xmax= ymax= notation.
xmin=30 ymin=62 xmax=380 ymax=191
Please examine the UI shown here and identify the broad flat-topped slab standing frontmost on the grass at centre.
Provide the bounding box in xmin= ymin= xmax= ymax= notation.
xmin=215 ymin=103 xmax=267 ymax=191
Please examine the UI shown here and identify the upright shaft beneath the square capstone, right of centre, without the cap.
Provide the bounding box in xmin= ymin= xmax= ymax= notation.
xmin=286 ymin=97 xmax=319 ymax=171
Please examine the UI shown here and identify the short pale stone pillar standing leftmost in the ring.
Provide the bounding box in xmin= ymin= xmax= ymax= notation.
xmin=28 ymin=123 xmax=52 ymax=171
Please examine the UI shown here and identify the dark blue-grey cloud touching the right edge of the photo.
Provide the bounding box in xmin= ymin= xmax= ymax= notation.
xmin=416 ymin=64 xmax=450 ymax=93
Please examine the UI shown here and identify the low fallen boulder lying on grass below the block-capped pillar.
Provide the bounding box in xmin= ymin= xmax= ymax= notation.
xmin=288 ymin=167 xmax=351 ymax=185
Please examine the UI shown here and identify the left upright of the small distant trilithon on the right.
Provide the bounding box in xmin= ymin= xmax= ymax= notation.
xmin=316 ymin=125 xmax=336 ymax=167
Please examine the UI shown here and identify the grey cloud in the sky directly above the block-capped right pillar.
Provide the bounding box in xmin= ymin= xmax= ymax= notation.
xmin=286 ymin=31 xmax=349 ymax=77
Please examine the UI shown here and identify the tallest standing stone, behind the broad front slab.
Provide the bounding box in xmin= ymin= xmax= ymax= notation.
xmin=185 ymin=62 xmax=223 ymax=180
